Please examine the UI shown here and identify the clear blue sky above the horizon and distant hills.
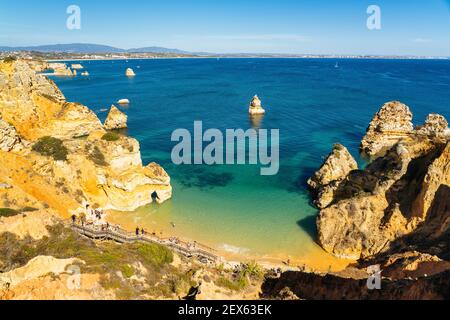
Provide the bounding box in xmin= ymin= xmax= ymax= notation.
xmin=0 ymin=0 xmax=450 ymax=56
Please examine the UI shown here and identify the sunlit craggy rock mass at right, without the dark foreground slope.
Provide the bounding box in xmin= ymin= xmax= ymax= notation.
xmin=309 ymin=102 xmax=450 ymax=260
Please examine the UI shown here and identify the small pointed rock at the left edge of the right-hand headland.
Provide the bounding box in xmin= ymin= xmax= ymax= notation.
xmin=308 ymin=144 xmax=358 ymax=208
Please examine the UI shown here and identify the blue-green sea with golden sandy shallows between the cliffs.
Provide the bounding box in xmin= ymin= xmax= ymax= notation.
xmin=54 ymin=59 xmax=450 ymax=268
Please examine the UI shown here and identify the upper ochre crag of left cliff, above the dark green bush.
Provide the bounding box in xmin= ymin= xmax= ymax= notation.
xmin=0 ymin=60 xmax=102 ymax=141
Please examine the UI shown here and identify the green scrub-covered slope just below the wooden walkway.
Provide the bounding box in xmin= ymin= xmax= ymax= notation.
xmin=0 ymin=225 xmax=192 ymax=299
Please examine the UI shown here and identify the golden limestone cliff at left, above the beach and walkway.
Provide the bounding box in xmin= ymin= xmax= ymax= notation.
xmin=0 ymin=60 xmax=172 ymax=216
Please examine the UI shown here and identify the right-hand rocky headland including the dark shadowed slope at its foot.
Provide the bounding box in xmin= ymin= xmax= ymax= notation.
xmin=263 ymin=101 xmax=450 ymax=299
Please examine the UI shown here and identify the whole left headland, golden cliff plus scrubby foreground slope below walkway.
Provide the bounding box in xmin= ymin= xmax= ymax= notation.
xmin=0 ymin=58 xmax=263 ymax=300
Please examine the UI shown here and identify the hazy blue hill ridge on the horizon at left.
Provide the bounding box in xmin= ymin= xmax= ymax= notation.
xmin=0 ymin=43 xmax=189 ymax=54
